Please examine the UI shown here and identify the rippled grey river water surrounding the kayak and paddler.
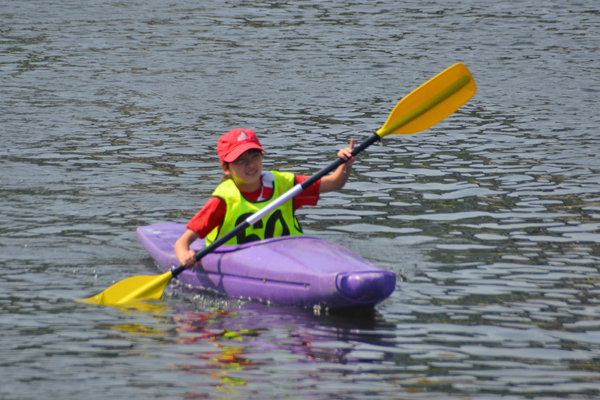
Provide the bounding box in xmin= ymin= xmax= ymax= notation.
xmin=0 ymin=0 xmax=600 ymax=400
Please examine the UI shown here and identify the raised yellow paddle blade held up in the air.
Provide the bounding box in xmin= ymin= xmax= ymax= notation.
xmin=377 ymin=63 xmax=477 ymax=138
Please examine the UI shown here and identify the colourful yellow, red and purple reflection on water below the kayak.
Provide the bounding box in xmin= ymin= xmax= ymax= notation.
xmin=100 ymin=302 xmax=395 ymax=396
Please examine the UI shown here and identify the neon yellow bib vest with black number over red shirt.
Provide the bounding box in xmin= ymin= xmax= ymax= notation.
xmin=206 ymin=171 xmax=302 ymax=246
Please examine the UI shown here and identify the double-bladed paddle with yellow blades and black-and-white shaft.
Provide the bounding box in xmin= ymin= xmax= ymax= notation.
xmin=81 ymin=63 xmax=477 ymax=305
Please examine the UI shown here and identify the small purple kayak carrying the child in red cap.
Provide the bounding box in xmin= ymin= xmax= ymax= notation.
xmin=137 ymin=223 xmax=396 ymax=309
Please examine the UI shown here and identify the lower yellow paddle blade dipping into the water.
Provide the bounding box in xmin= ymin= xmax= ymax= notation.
xmin=79 ymin=271 xmax=173 ymax=306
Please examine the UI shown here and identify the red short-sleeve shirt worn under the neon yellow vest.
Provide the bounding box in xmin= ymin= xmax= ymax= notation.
xmin=187 ymin=175 xmax=321 ymax=238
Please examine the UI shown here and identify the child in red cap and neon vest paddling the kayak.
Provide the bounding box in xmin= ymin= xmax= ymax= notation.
xmin=175 ymin=129 xmax=355 ymax=267
